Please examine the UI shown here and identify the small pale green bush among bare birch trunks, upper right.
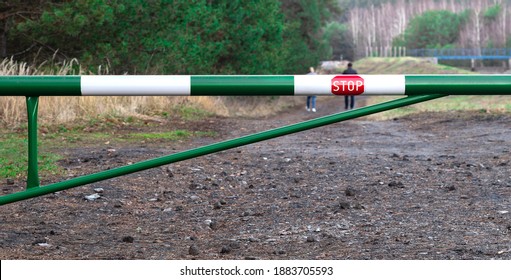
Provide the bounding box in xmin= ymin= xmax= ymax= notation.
xmin=394 ymin=10 xmax=463 ymax=49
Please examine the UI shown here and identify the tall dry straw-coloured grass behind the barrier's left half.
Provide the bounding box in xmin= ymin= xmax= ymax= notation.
xmin=0 ymin=59 xmax=293 ymax=127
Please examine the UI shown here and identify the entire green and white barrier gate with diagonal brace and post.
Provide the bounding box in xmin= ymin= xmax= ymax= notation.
xmin=0 ymin=75 xmax=511 ymax=205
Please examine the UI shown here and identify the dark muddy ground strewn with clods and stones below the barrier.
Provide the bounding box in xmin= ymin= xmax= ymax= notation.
xmin=0 ymin=98 xmax=511 ymax=260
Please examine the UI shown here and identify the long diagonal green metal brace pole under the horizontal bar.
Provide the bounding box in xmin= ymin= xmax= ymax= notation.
xmin=0 ymin=94 xmax=447 ymax=205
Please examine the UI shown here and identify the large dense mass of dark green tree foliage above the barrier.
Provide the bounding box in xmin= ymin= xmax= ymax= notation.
xmin=9 ymin=0 xmax=339 ymax=74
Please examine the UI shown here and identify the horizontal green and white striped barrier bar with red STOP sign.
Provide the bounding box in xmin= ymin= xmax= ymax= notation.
xmin=0 ymin=75 xmax=511 ymax=96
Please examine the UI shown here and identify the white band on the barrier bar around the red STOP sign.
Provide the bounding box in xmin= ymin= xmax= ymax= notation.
xmin=294 ymin=74 xmax=405 ymax=95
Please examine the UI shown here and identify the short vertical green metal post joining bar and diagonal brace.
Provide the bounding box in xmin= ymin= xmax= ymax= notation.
xmin=26 ymin=96 xmax=39 ymax=189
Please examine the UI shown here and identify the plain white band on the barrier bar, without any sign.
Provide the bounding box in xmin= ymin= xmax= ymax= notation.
xmin=81 ymin=75 xmax=191 ymax=96
